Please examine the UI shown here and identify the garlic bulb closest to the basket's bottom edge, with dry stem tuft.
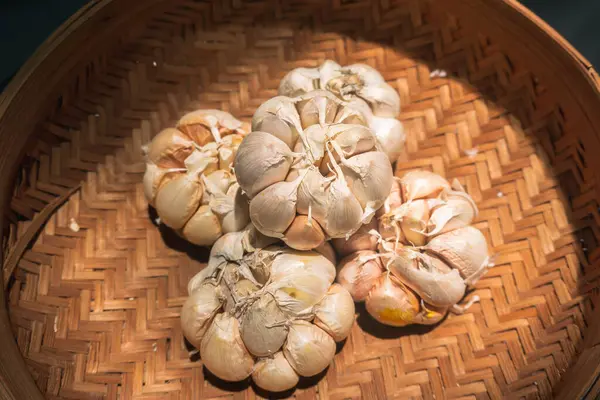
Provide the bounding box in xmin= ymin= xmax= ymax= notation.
xmin=181 ymin=225 xmax=354 ymax=392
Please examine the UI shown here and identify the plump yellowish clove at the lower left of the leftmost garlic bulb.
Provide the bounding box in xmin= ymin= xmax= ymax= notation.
xmin=155 ymin=171 xmax=204 ymax=230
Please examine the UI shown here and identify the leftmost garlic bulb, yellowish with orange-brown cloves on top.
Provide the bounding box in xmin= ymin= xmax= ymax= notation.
xmin=143 ymin=110 xmax=249 ymax=246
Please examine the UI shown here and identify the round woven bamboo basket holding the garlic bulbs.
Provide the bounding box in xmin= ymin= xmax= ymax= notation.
xmin=0 ymin=0 xmax=600 ymax=400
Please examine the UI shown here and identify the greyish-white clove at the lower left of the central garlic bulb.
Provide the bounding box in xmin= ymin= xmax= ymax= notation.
xmin=250 ymin=181 xmax=298 ymax=238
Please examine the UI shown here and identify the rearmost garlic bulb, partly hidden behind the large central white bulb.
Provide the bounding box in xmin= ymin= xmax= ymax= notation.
xmin=279 ymin=60 xmax=405 ymax=162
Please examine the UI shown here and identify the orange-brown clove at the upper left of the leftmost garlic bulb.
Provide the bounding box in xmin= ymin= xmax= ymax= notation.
xmin=145 ymin=128 xmax=194 ymax=168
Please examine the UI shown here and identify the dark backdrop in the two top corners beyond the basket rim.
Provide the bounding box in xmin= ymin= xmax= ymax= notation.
xmin=0 ymin=0 xmax=600 ymax=91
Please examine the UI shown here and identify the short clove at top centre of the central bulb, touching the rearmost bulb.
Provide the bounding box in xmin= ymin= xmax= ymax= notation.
xmin=296 ymin=90 xmax=339 ymax=128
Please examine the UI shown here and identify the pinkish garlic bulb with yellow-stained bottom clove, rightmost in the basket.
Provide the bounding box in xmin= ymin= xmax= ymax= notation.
xmin=333 ymin=170 xmax=490 ymax=326
